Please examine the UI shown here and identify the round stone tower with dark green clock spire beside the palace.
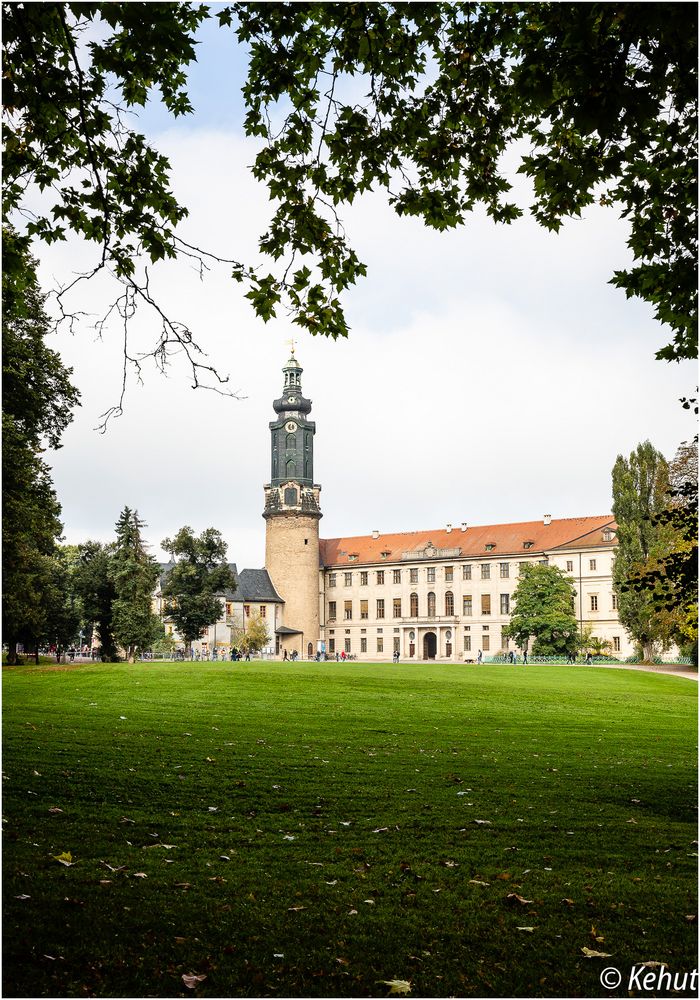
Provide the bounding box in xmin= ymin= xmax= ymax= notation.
xmin=263 ymin=350 xmax=321 ymax=657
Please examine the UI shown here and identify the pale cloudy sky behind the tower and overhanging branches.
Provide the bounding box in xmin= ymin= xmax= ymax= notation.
xmin=37 ymin=13 xmax=695 ymax=569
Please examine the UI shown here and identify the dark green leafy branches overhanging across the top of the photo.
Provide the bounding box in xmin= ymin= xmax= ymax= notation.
xmin=3 ymin=2 xmax=697 ymax=406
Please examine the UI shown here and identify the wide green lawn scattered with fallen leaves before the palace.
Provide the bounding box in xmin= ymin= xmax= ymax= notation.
xmin=3 ymin=663 xmax=697 ymax=997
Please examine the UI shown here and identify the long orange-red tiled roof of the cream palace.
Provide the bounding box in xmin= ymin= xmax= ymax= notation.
xmin=321 ymin=514 xmax=615 ymax=566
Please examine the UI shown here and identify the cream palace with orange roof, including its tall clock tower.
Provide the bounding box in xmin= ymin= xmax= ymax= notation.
xmin=161 ymin=351 xmax=632 ymax=663
